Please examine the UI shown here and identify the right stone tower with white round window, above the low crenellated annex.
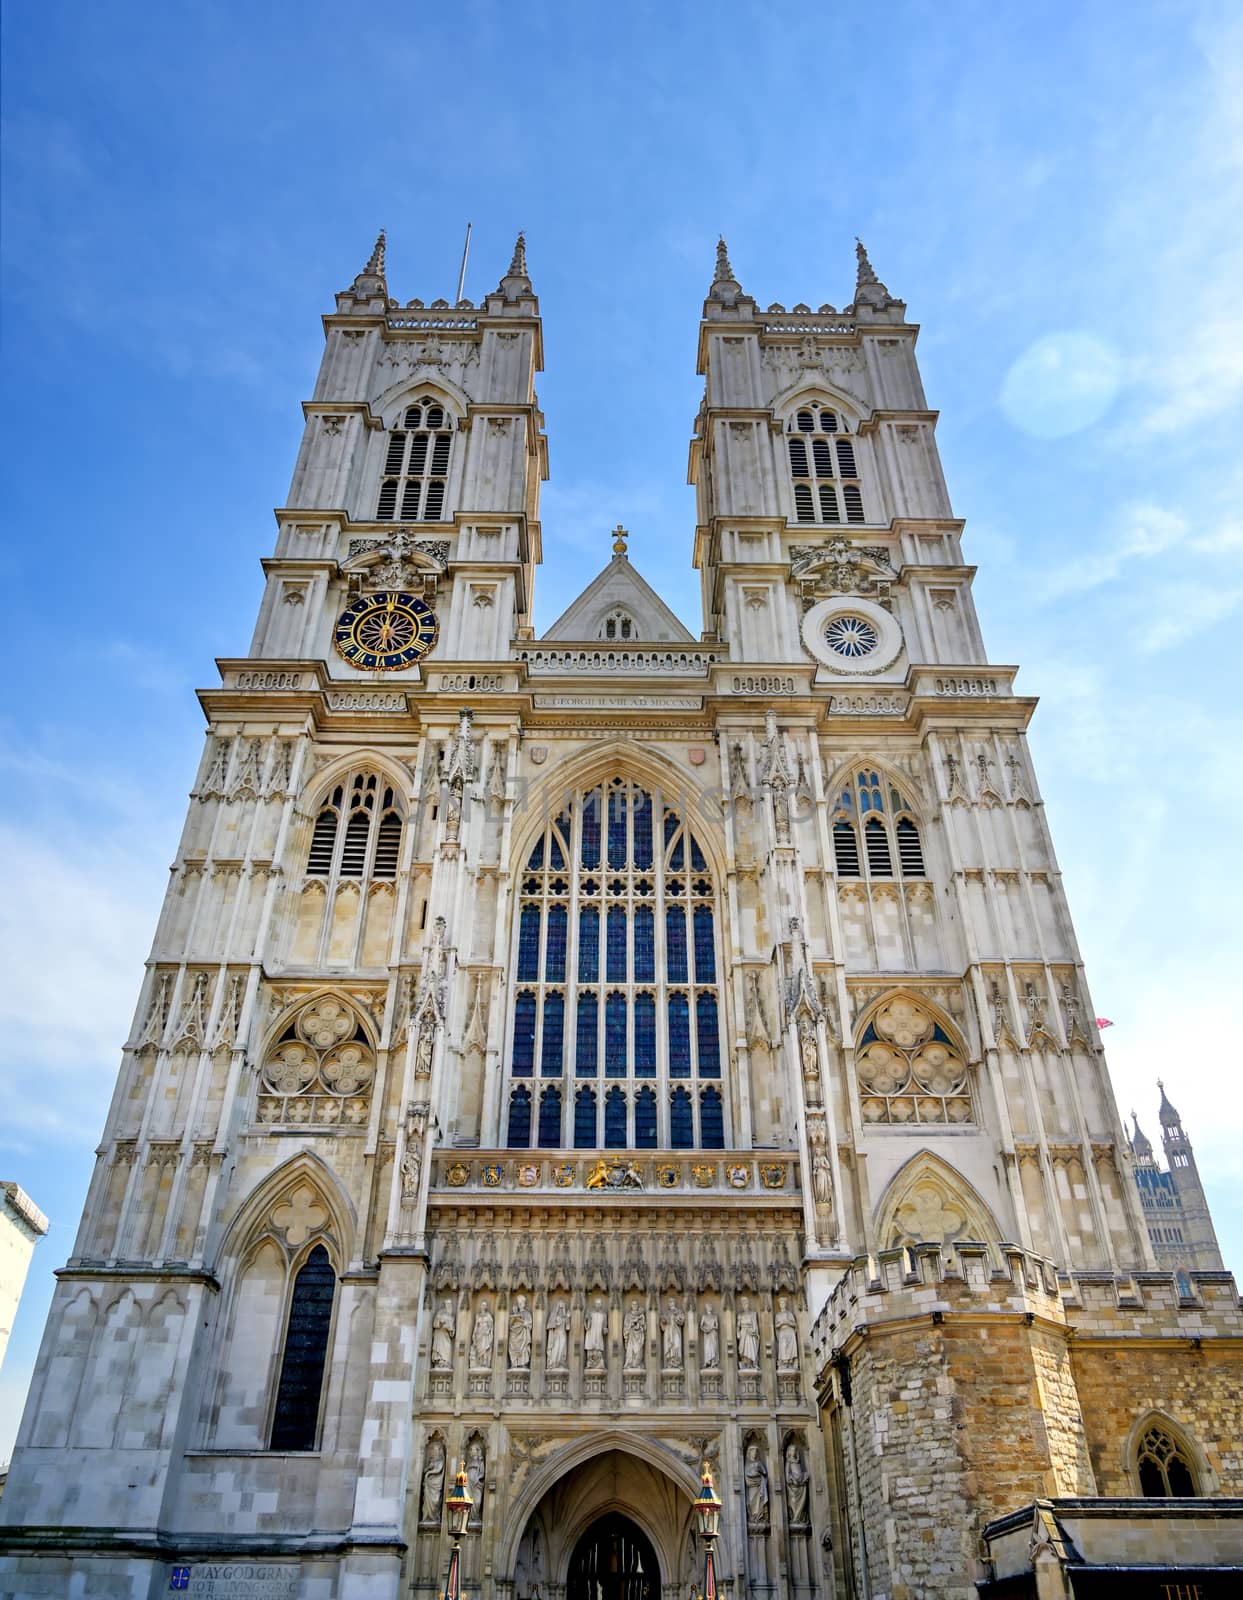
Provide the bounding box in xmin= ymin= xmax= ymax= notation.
xmin=691 ymin=236 xmax=1153 ymax=1272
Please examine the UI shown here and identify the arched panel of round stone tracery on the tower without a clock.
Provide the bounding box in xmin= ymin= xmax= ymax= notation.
xmin=854 ymin=995 xmax=971 ymax=1123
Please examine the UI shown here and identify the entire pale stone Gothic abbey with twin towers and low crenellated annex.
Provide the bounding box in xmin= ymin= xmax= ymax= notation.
xmin=0 ymin=228 xmax=1235 ymax=1600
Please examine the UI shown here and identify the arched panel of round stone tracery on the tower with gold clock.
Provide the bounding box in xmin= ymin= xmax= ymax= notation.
xmin=258 ymin=995 xmax=376 ymax=1128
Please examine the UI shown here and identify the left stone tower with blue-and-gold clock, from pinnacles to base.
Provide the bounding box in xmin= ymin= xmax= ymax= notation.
xmin=0 ymin=235 xmax=547 ymax=1597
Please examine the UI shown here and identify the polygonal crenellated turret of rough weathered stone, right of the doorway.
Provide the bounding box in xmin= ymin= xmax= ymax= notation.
xmin=813 ymin=1246 xmax=1093 ymax=1600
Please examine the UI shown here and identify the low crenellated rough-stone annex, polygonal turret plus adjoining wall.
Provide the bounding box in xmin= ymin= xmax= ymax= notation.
xmin=813 ymin=1245 xmax=1243 ymax=1600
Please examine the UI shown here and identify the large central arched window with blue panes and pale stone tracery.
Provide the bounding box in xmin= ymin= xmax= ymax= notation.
xmin=502 ymin=778 xmax=728 ymax=1150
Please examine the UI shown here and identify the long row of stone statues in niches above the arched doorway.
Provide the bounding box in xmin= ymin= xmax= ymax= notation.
xmin=430 ymin=1293 xmax=800 ymax=1373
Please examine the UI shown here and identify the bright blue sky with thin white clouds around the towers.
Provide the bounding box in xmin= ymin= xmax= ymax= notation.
xmin=0 ymin=0 xmax=1243 ymax=1461
